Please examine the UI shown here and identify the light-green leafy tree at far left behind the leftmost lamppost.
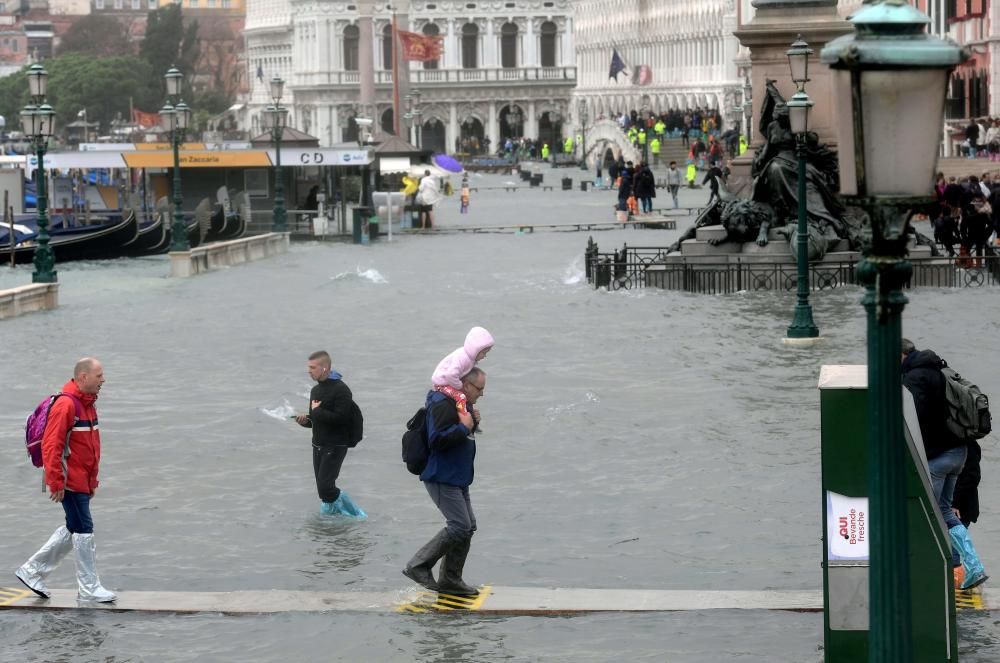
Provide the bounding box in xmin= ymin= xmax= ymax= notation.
xmin=0 ymin=53 xmax=163 ymax=137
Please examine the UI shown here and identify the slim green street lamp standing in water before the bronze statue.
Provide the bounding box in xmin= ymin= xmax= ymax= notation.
xmin=785 ymin=35 xmax=819 ymax=344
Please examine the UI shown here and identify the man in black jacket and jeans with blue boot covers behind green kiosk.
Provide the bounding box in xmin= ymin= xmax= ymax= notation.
xmin=902 ymin=338 xmax=987 ymax=589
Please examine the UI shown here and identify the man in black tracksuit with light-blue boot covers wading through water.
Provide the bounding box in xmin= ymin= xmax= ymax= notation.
xmin=295 ymin=350 xmax=366 ymax=520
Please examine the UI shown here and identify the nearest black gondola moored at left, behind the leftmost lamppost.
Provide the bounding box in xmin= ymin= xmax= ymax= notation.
xmin=0 ymin=210 xmax=139 ymax=264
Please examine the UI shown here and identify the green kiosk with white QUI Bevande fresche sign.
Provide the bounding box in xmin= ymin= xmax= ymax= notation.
xmin=819 ymin=365 xmax=958 ymax=663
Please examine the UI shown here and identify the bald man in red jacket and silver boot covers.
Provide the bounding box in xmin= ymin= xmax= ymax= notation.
xmin=14 ymin=357 xmax=118 ymax=603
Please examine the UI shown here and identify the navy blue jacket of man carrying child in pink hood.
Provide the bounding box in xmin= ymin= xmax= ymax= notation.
xmin=420 ymin=391 xmax=476 ymax=488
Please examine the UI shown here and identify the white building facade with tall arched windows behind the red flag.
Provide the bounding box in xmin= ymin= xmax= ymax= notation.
xmin=245 ymin=0 xmax=577 ymax=152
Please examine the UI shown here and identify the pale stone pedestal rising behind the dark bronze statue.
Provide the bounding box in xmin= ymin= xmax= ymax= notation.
xmin=729 ymin=0 xmax=854 ymax=195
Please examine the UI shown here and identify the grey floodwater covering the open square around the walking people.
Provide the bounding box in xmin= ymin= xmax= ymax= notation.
xmin=0 ymin=173 xmax=1000 ymax=663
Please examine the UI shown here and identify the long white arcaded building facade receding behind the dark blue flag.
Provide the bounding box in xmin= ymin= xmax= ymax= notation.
xmin=574 ymin=0 xmax=742 ymax=128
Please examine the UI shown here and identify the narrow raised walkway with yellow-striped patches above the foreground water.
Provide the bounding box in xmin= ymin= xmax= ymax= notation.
xmin=0 ymin=585 xmax=984 ymax=615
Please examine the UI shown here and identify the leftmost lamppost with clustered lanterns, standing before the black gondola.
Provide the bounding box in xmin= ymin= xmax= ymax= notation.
xmin=21 ymin=64 xmax=57 ymax=283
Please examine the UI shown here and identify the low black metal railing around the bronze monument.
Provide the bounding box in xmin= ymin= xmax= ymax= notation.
xmin=584 ymin=238 xmax=1000 ymax=295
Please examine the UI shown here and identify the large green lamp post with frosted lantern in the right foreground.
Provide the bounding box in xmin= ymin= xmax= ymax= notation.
xmin=821 ymin=0 xmax=968 ymax=663
